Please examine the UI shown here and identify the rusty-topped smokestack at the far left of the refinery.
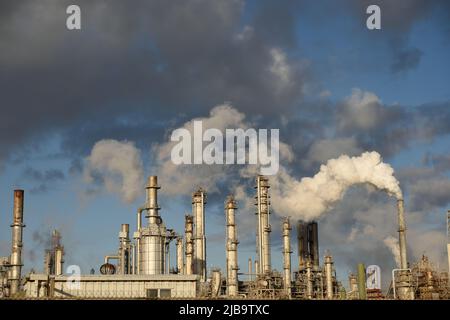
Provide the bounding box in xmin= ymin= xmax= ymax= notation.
xmin=9 ymin=190 xmax=25 ymax=295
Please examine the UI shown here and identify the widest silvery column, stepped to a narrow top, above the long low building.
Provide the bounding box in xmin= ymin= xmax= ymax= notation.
xmin=139 ymin=176 xmax=166 ymax=274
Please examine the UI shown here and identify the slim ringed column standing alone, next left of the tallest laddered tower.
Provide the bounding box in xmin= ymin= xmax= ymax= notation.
xmin=225 ymin=196 xmax=239 ymax=297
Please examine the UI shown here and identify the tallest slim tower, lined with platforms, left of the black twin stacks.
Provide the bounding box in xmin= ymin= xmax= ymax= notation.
xmin=256 ymin=176 xmax=271 ymax=274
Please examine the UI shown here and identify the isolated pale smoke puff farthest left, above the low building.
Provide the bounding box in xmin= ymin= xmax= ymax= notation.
xmin=84 ymin=140 xmax=144 ymax=202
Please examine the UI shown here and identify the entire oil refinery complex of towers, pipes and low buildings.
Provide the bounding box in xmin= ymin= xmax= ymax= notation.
xmin=0 ymin=176 xmax=450 ymax=300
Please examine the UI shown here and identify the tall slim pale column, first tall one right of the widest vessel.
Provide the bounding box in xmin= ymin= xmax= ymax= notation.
xmin=192 ymin=188 xmax=206 ymax=281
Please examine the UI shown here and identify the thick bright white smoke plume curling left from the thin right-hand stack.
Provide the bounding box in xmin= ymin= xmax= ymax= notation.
xmin=271 ymin=151 xmax=402 ymax=220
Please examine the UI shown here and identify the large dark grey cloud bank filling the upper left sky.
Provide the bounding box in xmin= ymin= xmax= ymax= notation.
xmin=0 ymin=0 xmax=306 ymax=169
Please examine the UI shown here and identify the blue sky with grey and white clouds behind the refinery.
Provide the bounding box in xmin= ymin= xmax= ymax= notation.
xmin=0 ymin=0 xmax=450 ymax=285
